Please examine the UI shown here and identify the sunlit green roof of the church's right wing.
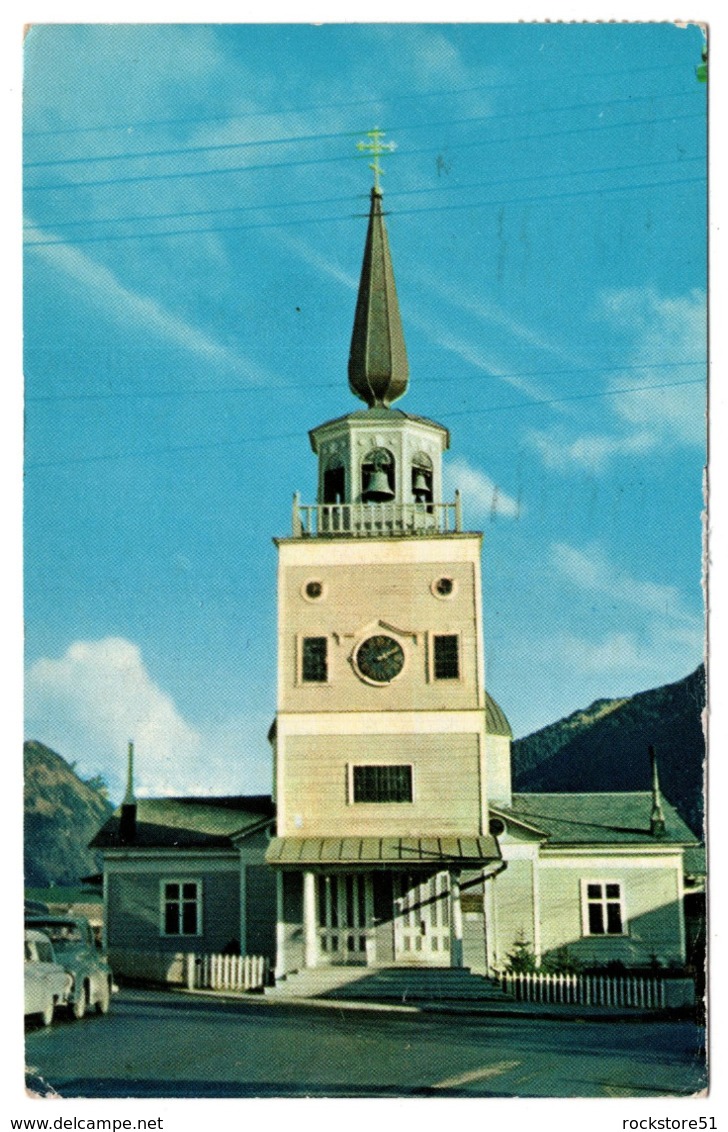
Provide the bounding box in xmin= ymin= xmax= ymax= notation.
xmin=490 ymin=790 xmax=699 ymax=846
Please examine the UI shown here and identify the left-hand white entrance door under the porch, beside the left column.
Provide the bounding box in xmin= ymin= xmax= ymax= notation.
xmin=318 ymin=873 xmax=375 ymax=963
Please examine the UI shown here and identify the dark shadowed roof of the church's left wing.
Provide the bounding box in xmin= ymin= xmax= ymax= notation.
xmin=91 ymin=795 xmax=275 ymax=849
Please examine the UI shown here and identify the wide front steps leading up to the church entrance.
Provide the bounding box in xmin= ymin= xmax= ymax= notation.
xmin=266 ymin=967 xmax=513 ymax=1005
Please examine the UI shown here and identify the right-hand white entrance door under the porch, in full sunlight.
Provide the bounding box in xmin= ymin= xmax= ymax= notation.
xmin=394 ymin=873 xmax=449 ymax=967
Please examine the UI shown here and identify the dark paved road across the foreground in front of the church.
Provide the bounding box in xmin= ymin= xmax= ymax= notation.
xmin=26 ymin=991 xmax=704 ymax=1098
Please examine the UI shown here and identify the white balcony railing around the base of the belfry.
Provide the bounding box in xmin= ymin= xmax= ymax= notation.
xmin=293 ymin=491 xmax=462 ymax=539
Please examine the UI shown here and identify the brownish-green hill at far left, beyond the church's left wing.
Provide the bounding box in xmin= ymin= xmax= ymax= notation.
xmin=23 ymin=740 xmax=112 ymax=889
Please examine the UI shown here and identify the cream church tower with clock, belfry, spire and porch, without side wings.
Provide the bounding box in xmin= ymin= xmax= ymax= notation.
xmin=267 ymin=150 xmax=509 ymax=976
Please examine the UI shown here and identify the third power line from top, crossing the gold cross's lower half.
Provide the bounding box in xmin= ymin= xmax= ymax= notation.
xmin=25 ymin=111 xmax=705 ymax=192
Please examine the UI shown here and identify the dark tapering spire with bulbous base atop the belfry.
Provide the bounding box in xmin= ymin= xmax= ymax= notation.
xmin=349 ymin=186 xmax=409 ymax=409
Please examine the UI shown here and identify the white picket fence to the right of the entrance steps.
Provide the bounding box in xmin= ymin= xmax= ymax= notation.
xmin=498 ymin=971 xmax=666 ymax=1010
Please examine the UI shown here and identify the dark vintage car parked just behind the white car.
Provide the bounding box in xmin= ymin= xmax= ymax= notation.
xmin=25 ymin=915 xmax=113 ymax=1018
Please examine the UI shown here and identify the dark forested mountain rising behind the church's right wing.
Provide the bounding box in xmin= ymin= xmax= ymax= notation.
xmin=513 ymin=664 xmax=705 ymax=837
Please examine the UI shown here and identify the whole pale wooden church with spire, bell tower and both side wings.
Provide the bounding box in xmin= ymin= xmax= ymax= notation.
xmin=94 ymin=155 xmax=699 ymax=980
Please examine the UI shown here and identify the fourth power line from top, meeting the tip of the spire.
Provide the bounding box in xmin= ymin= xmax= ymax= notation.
xmin=23 ymin=155 xmax=705 ymax=231
